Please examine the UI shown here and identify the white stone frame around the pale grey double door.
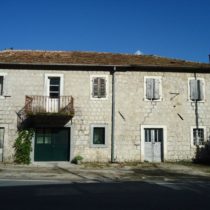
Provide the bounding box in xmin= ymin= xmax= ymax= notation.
xmin=140 ymin=125 xmax=167 ymax=162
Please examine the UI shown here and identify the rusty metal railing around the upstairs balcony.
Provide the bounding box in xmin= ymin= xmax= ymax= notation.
xmin=24 ymin=96 xmax=74 ymax=117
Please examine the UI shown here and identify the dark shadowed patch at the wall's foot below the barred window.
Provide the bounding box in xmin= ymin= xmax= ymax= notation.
xmin=193 ymin=141 xmax=210 ymax=165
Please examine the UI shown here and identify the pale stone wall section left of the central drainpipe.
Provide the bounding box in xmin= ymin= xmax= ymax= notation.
xmin=0 ymin=69 xmax=111 ymax=162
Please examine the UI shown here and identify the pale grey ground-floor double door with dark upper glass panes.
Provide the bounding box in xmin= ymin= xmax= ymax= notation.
xmin=144 ymin=128 xmax=163 ymax=162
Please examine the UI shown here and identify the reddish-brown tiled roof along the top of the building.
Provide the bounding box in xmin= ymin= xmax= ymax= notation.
xmin=0 ymin=50 xmax=210 ymax=68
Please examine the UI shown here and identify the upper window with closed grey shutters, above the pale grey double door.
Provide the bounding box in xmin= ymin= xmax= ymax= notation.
xmin=144 ymin=77 xmax=162 ymax=101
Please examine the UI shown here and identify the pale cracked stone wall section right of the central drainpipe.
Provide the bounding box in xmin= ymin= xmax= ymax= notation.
xmin=116 ymin=72 xmax=210 ymax=161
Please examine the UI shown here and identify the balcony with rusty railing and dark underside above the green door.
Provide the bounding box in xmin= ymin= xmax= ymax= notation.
xmin=17 ymin=96 xmax=74 ymax=127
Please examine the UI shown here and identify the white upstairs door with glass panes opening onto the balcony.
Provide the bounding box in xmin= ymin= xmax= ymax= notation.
xmin=46 ymin=77 xmax=60 ymax=112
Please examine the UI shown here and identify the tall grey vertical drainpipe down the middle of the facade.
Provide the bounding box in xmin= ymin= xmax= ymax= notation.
xmin=111 ymin=66 xmax=116 ymax=163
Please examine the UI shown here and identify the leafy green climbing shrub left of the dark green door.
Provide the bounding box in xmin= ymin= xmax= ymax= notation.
xmin=13 ymin=130 xmax=34 ymax=164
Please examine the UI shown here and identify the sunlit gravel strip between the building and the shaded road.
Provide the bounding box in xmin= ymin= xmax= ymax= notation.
xmin=0 ymin=163 xmax=210 ymax=182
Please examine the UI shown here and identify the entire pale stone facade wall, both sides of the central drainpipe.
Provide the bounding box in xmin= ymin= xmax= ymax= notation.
xmin=0 ymin=69 xmax=210 ymax=162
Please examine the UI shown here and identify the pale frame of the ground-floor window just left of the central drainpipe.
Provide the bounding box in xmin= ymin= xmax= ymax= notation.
xmin=90 ymin=123 xmax=108 ymax=148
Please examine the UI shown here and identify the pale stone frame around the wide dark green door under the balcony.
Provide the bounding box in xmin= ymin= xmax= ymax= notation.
xmin=30 ymin=125 xmax=73 ymax=164
